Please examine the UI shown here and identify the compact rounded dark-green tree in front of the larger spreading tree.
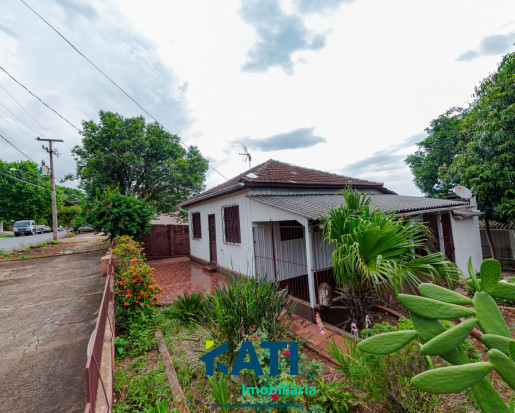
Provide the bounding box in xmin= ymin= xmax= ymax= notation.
xmin=86 ymin=190 xmax=156 ymax=239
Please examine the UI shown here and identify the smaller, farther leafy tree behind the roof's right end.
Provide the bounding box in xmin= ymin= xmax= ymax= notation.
xmin=405 ymin=108 xmax=466 ymax=198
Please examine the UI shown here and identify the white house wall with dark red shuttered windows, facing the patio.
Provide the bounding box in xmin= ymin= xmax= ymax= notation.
xmin=188 ymin=190 xmax=254 ymax=275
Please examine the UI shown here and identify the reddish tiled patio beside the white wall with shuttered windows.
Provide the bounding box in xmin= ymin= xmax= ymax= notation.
xmin=148 ymin=257 xmax=222 ymax=305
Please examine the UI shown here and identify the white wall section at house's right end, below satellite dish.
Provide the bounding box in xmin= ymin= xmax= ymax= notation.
xmin=451 ymin=214 xmax=483 ymax=278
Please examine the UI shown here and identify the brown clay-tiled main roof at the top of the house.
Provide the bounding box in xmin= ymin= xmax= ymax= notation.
xmin=179 ymin=159 xmax=394 ymax=206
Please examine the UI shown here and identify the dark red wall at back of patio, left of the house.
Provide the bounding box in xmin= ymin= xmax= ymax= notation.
xmin=141 ymin=224 xmax=190 ymax=258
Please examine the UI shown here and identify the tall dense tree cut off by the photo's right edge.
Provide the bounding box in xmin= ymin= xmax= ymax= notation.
xmin=448 ymin=53 xmax=515 ymax=259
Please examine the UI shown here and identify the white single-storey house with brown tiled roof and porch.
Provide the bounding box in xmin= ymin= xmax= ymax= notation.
xmin=180 ymin=159 xmax=482 ymax=308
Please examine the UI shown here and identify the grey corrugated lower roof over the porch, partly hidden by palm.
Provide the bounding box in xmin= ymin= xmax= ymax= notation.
xmin=247 ymin=194 xmax=468 ymax=219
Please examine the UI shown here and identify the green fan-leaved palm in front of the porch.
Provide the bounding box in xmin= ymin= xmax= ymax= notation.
xmin=320 ymin=189 xmax=459 ymax=328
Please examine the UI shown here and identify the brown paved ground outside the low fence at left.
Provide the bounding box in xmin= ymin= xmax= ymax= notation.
xmin=0 ymin=251 xmax=105 ymax=413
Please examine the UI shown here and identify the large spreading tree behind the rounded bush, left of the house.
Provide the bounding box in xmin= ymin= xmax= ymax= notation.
xmin=72 ymin=111 xmax=208 ymax=213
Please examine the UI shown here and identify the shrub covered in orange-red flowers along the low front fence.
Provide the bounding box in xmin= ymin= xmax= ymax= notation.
xmin=113 ymin=236 xmax=162 ymax=315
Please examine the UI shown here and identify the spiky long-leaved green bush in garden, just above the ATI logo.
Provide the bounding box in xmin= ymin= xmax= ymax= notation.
xmin=202 ymin=274 xmax=293 ymax=361
